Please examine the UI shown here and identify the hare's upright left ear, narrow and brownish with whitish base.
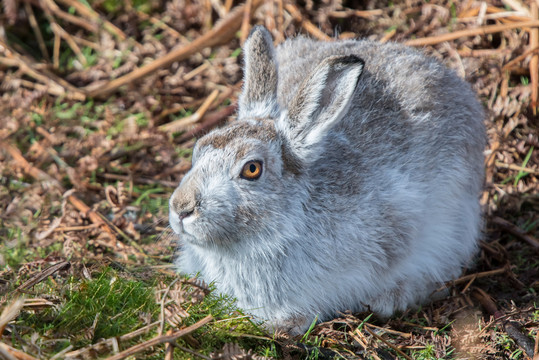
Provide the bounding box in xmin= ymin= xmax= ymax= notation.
xmin=239 ymin=26 xmax=279 ymax=119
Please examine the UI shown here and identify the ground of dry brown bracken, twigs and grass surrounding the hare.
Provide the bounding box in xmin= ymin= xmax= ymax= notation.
xmin=0 ymin=0 xmax=539 ymax=360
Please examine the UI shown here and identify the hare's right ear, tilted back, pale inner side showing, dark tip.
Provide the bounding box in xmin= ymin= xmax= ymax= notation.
xmin=288 ymin=55 xmax=365 ymax=152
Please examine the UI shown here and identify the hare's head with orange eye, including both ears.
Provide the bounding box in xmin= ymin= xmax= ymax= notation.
xmin=170 ymin=27 xmax=363 ymax=247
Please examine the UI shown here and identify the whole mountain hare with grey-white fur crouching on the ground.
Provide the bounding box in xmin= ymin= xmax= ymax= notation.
xmin=170 ymin=26 xmax=485 ymax=333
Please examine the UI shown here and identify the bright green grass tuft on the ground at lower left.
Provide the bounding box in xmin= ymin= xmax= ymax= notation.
xmin=19 ymin=268 xmax=159 ymax=347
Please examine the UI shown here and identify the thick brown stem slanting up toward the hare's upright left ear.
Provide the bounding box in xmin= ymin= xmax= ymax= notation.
xmin=87 ymin=0 xmax=262 ymax=97
